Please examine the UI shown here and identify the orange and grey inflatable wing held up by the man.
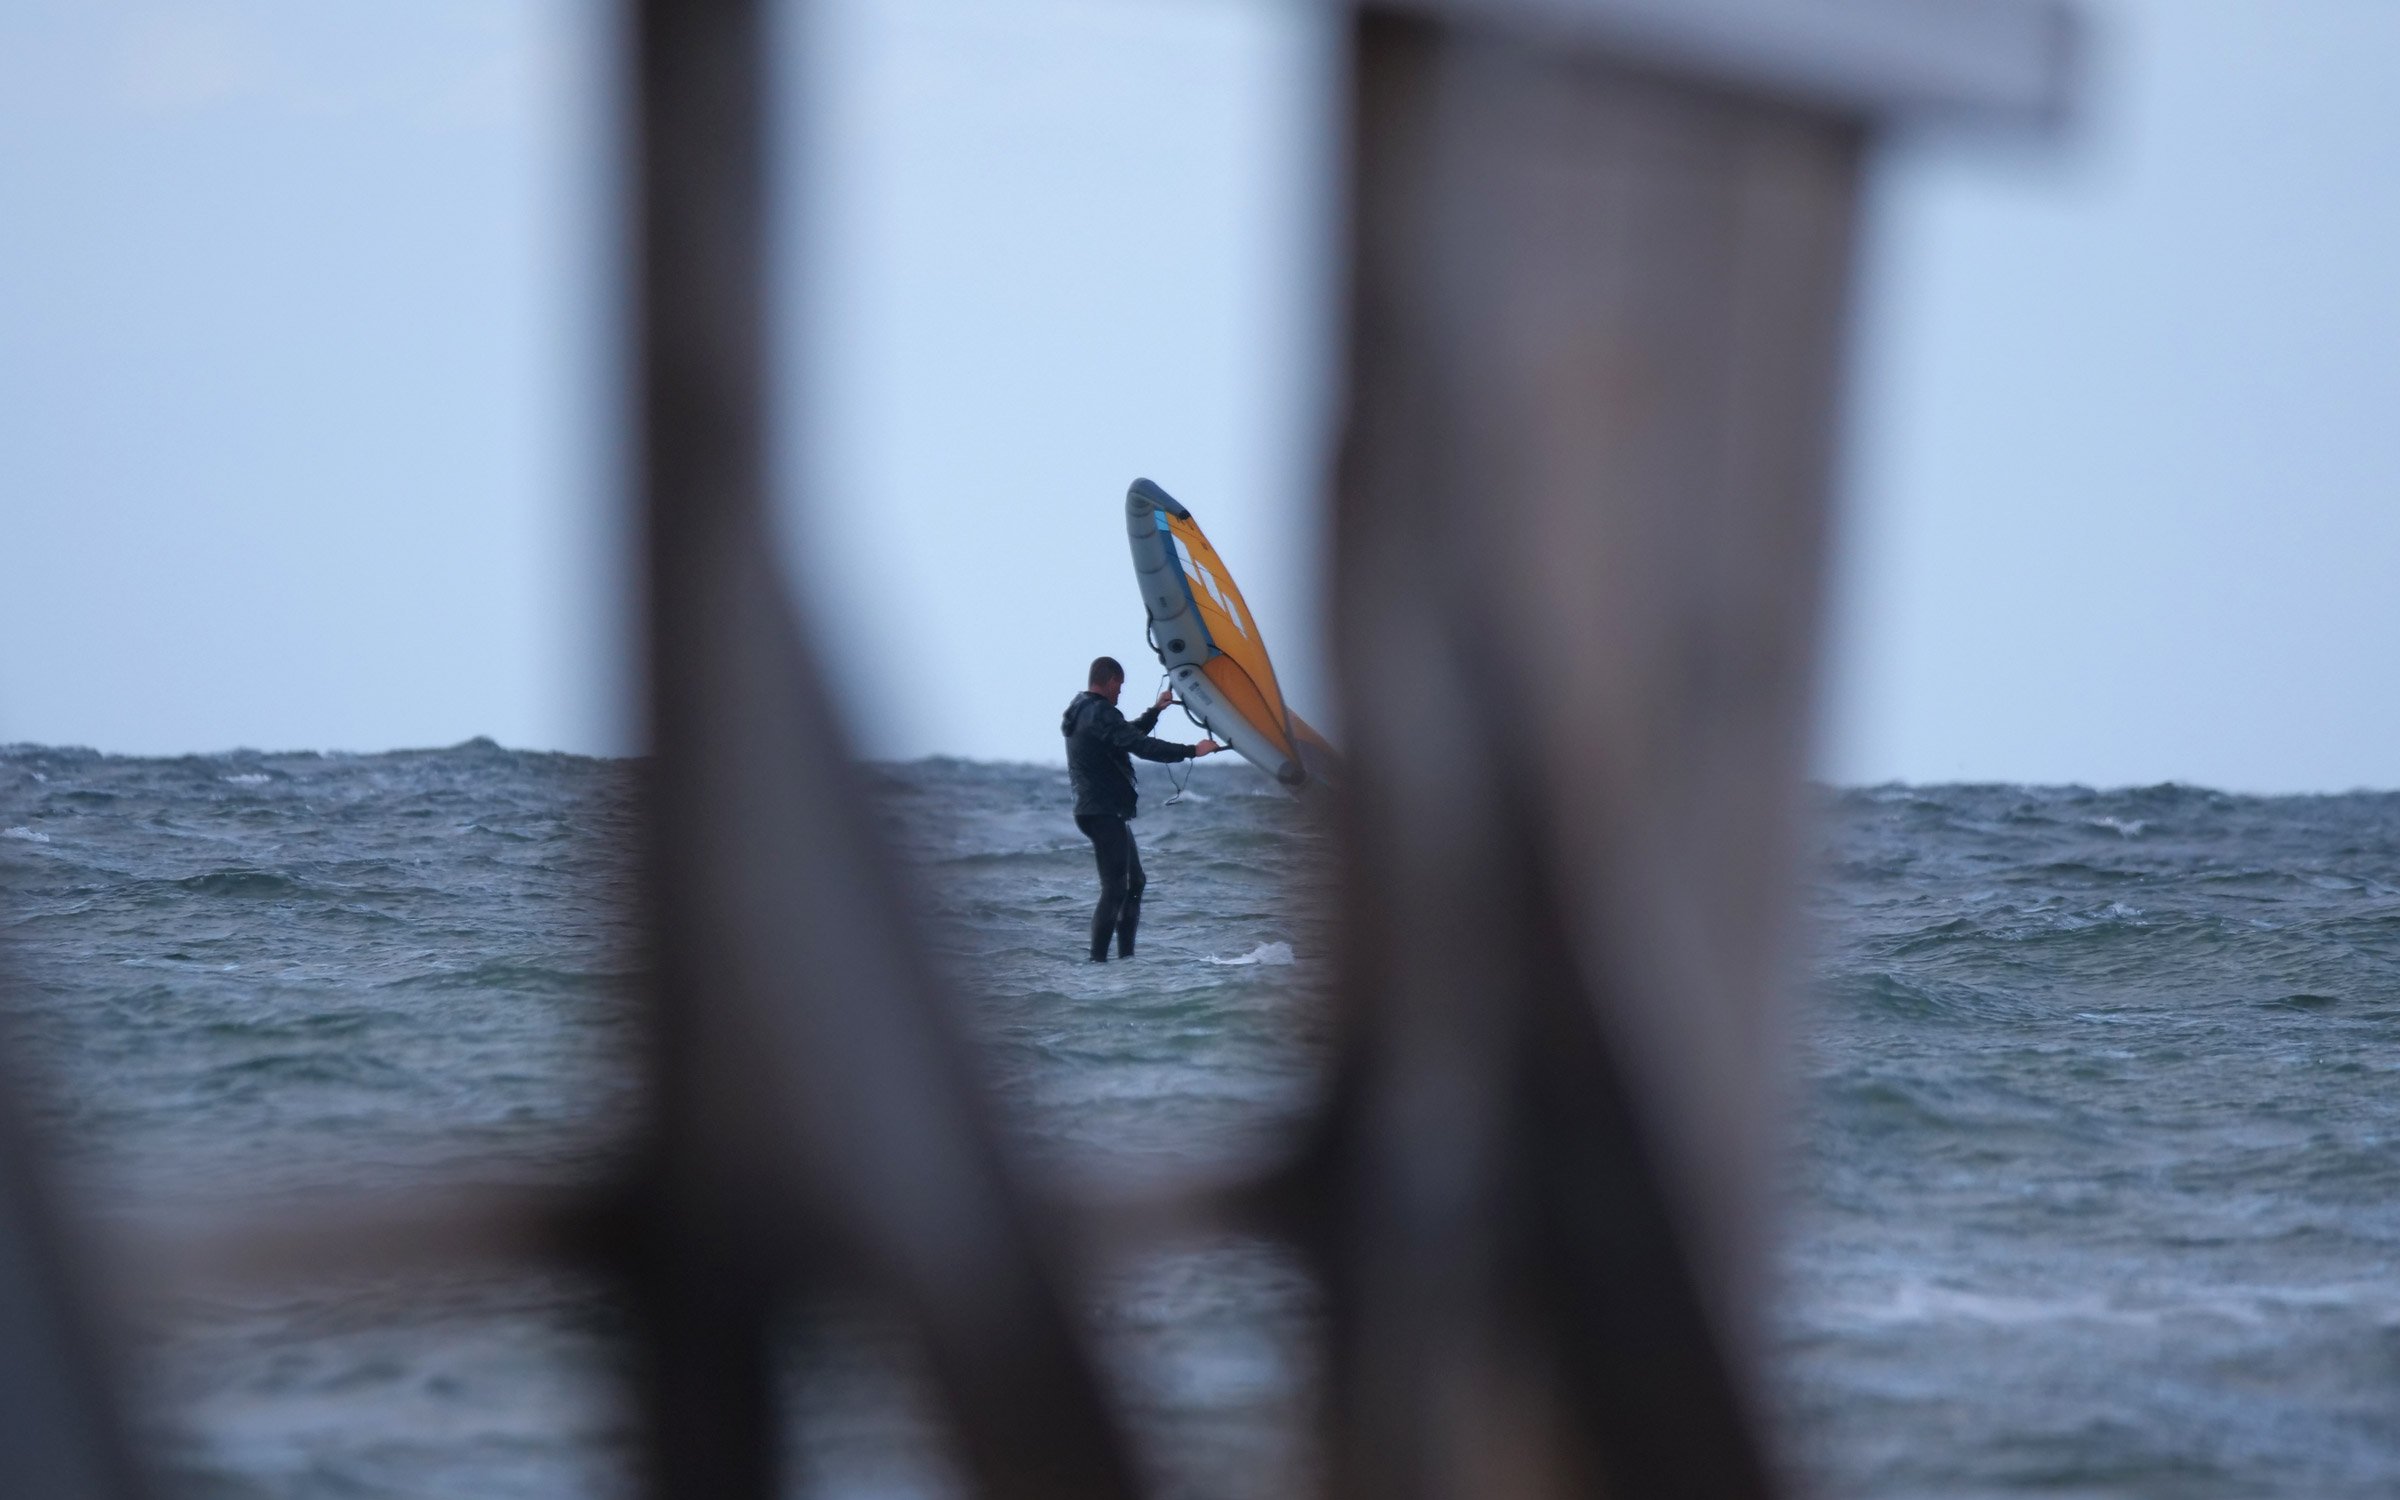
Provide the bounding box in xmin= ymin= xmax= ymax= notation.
xmin=1126 ymin=480 xmax=1342 ymax=787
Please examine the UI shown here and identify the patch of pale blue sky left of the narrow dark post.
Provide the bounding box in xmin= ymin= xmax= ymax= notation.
xmin=0 ymin=0 xmax=607 ymax=751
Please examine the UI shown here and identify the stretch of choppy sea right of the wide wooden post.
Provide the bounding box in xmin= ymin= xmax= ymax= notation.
xmin=1783 ymin=787 xmax=2400 ymax=1495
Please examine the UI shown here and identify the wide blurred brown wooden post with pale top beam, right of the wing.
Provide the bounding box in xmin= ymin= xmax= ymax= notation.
xmin=1330 ymin=0 xmax=2062 ymax=1500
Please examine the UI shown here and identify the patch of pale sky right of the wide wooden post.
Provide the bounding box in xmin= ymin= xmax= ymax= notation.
xmin=1826 ymin=0 xmax=2400 ymax=790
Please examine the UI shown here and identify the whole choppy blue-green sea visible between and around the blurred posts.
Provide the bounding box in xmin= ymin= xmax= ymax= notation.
xmin=0 ymin=742 xmax=2400 ymax=1498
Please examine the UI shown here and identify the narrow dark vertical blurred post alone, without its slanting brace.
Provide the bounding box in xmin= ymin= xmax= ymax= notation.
xmin=634 ymin=0 xmax=780 ymax=1500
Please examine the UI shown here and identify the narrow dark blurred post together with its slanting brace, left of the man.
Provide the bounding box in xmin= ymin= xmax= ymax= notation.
xmin=634 ymin=0 xmax=1135 ymax=1500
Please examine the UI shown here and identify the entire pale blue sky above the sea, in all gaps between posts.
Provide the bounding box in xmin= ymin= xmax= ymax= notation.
xmin=0 ymin=0 xmax=2400 ymax=790
